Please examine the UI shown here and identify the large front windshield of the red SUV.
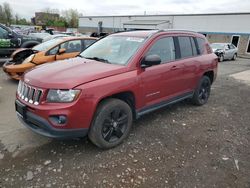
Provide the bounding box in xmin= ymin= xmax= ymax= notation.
xmin=80 ymin=36 xmax=144 ymax=65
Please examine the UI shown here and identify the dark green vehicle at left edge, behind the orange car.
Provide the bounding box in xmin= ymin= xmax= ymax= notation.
xmin=0 ymin=24 xmax=42 ymax=58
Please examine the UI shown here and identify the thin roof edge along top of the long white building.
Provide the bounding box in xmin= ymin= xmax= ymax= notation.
xmin=79 ymin=12 xmax=250 ymax=18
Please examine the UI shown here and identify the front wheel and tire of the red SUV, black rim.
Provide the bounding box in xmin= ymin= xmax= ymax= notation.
xmin=88 ymin=99 xmax=133 ymax=149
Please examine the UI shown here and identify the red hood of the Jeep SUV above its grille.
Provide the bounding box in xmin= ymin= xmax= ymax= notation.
xmin=24 ymin=57 xmax=127 ymax=89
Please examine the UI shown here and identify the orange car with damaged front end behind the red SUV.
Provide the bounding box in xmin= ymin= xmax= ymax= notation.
xmin=3 ymin=37 xmax=97 ymax=80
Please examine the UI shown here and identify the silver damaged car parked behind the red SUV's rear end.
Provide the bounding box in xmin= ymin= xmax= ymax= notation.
xmin=211 ymin=43 xmax=238 ymax=62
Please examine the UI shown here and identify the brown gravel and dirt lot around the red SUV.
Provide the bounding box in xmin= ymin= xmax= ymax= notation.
xmin=0 ymin=59 xmax=250 ymax=187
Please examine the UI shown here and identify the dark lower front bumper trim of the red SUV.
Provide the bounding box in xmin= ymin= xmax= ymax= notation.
xmin=16 ymin=100 xmax=88 ymax=138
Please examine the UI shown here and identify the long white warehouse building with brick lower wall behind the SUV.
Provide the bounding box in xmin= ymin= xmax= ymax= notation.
xmin=79 ymin=13 xmax=250 ymax=57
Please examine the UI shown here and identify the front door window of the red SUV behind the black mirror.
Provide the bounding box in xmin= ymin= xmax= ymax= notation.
xmin=146 ymin=37 xmax=175 ymax=63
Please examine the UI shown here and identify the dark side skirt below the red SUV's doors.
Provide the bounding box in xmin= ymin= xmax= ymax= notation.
xmin=136 ymin=91 xmax=194 ymax=119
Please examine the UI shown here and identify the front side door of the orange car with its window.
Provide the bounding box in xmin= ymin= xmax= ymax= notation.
xmin=56 ymin=40 xmax=82 ymax=60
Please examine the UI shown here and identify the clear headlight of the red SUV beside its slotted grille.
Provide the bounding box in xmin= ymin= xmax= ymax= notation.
xmin=47 ymin=89 xmax=80 ymax=103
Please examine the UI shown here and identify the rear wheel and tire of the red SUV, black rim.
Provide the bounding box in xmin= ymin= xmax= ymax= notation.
xmin=192 ymin=76 xmax=211 ymax=106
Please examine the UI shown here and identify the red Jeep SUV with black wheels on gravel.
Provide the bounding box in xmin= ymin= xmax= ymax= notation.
xmin=15 ymin=30 xmax=218 ymax=148
